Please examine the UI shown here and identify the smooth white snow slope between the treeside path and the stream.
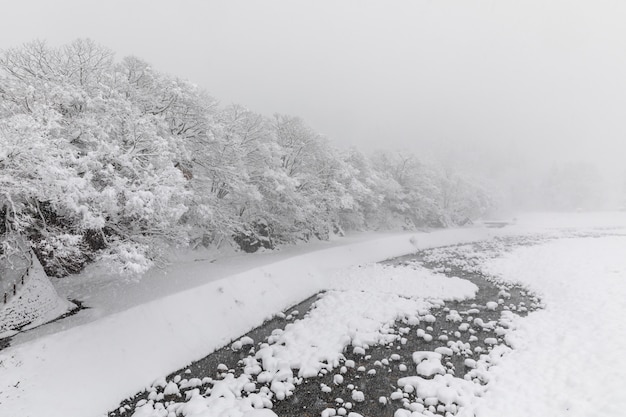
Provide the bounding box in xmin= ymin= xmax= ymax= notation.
xmin=0 ymin=228 xmax=491 ymax=417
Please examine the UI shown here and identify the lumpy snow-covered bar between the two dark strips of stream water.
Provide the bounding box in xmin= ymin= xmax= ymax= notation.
xmin=128 ymin=266 xmax=477 ymax=417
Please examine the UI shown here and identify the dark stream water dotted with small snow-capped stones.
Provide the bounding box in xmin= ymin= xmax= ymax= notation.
xmin=109 ymin=239 xmax=540 ymax=417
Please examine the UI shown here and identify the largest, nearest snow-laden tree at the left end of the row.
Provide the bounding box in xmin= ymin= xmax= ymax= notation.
xmin=0 ymin=40 xmax=186 ymax=275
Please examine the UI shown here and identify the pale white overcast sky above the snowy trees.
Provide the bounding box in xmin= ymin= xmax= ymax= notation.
xmin=0 ymin=0 xmax=626 ymax=177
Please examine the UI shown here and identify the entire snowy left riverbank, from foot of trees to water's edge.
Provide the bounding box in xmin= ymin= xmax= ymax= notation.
xmin=0 ymin=213 xmax=626 ymax=417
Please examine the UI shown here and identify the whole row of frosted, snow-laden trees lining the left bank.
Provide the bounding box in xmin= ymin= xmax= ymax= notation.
xmin=0 ymin=40 xmax=491 ymax=276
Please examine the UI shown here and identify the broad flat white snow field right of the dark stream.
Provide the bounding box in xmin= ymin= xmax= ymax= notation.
xmin=462 ymin=236 xmax=626 ymax=417
